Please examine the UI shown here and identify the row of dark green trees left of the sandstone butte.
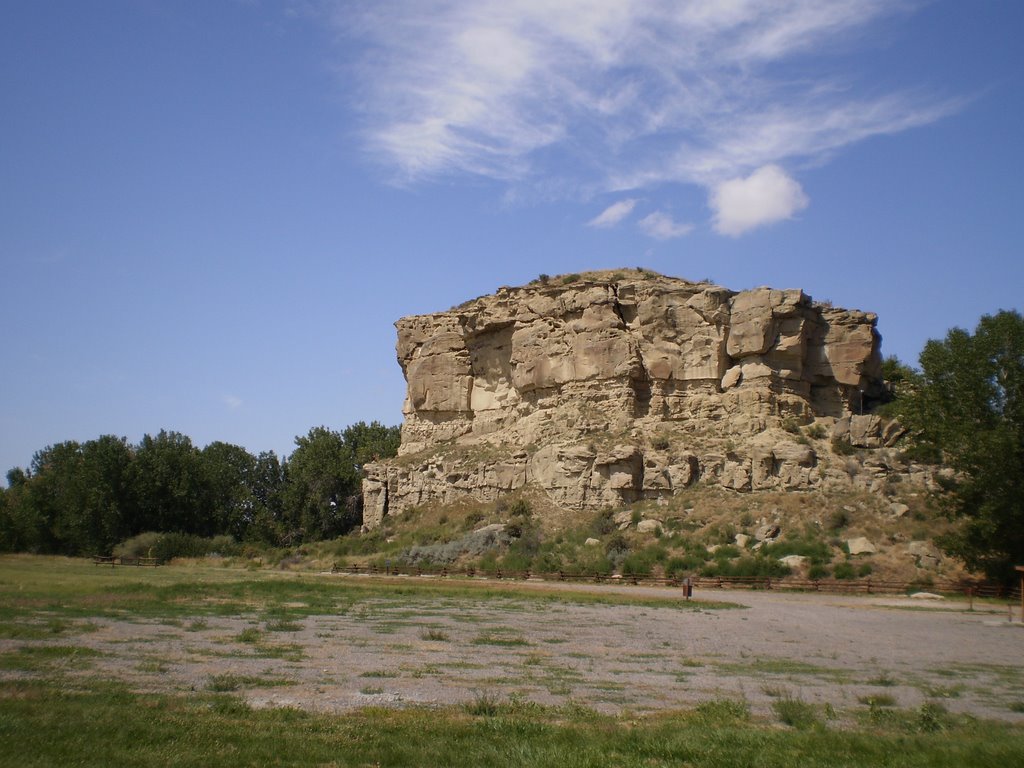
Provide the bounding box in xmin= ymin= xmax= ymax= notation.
xmin=0 ymin=422 xmax=400 ymax=555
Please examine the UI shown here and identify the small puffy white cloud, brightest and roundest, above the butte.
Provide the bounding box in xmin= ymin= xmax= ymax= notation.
xmin=710 ymin=165 xmax=810 ymax=238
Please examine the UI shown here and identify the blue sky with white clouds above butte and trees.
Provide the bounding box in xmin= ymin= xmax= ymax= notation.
xmin=0 ymin=0 xmax=1024 ymax=481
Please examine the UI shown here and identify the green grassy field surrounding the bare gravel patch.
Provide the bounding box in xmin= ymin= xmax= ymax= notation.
xmin=0 ymin=556 xmax=1024 ymax=768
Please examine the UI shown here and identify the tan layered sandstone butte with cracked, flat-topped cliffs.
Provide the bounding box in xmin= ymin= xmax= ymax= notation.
xmin=362 ymin=269 xmax=929 ymax=529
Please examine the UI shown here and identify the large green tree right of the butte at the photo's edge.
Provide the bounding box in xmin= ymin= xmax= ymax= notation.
xmin=895 ymin=311 xmax=1024 ymax=581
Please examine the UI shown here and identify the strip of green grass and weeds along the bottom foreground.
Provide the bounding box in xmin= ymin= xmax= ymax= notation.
xmin=0 ymin=678 xmax=1024 ymax=768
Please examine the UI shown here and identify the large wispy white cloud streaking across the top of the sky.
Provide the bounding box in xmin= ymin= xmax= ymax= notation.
xmin=332 ymin=0 xmax=961 ymax=234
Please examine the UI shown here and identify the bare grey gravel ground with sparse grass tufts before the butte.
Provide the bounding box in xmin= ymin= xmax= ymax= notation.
xmin=22 ymin=575 xmax=1024 ymax=722
